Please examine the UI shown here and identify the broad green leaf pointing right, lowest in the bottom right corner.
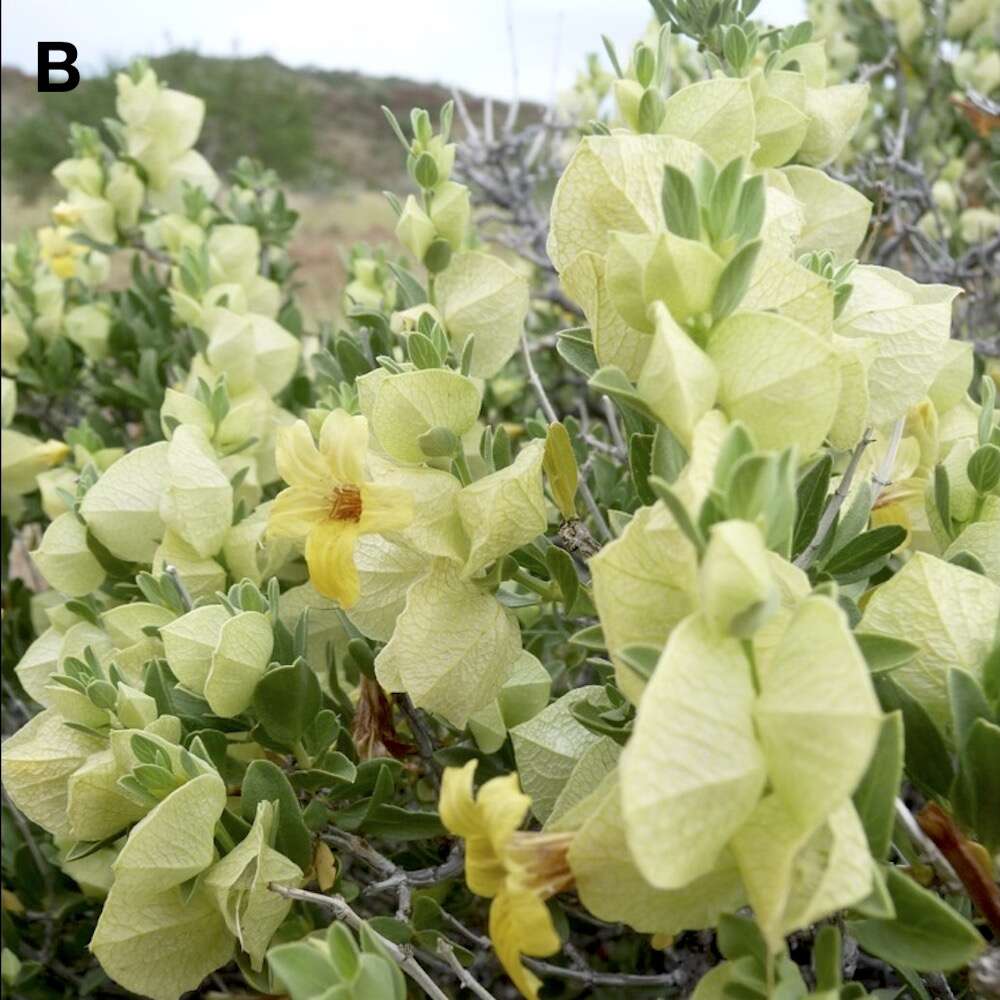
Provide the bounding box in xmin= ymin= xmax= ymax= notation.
xmin=846 ymin=868 xmax=985 ymax=972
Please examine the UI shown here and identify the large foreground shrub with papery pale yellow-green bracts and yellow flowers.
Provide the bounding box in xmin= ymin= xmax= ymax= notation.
xmin=3 ymin=11 xmax=1000 ymax=1000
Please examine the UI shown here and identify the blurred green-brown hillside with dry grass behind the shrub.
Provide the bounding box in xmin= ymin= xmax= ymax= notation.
xmin=0 ymin=50 xmax=539 ymax=317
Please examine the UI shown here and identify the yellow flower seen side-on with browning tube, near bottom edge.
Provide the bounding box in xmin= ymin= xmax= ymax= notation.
xmin=439 ymin=760 xmax=573 ymax=1000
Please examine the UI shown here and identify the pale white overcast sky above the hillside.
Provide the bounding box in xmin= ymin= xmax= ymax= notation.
xmin=0 ymin=0 xmax=804 ymax=101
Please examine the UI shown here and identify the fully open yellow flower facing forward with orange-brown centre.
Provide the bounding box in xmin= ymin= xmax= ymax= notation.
xmin=268 ymin=410 xmax=413 ymax=608
